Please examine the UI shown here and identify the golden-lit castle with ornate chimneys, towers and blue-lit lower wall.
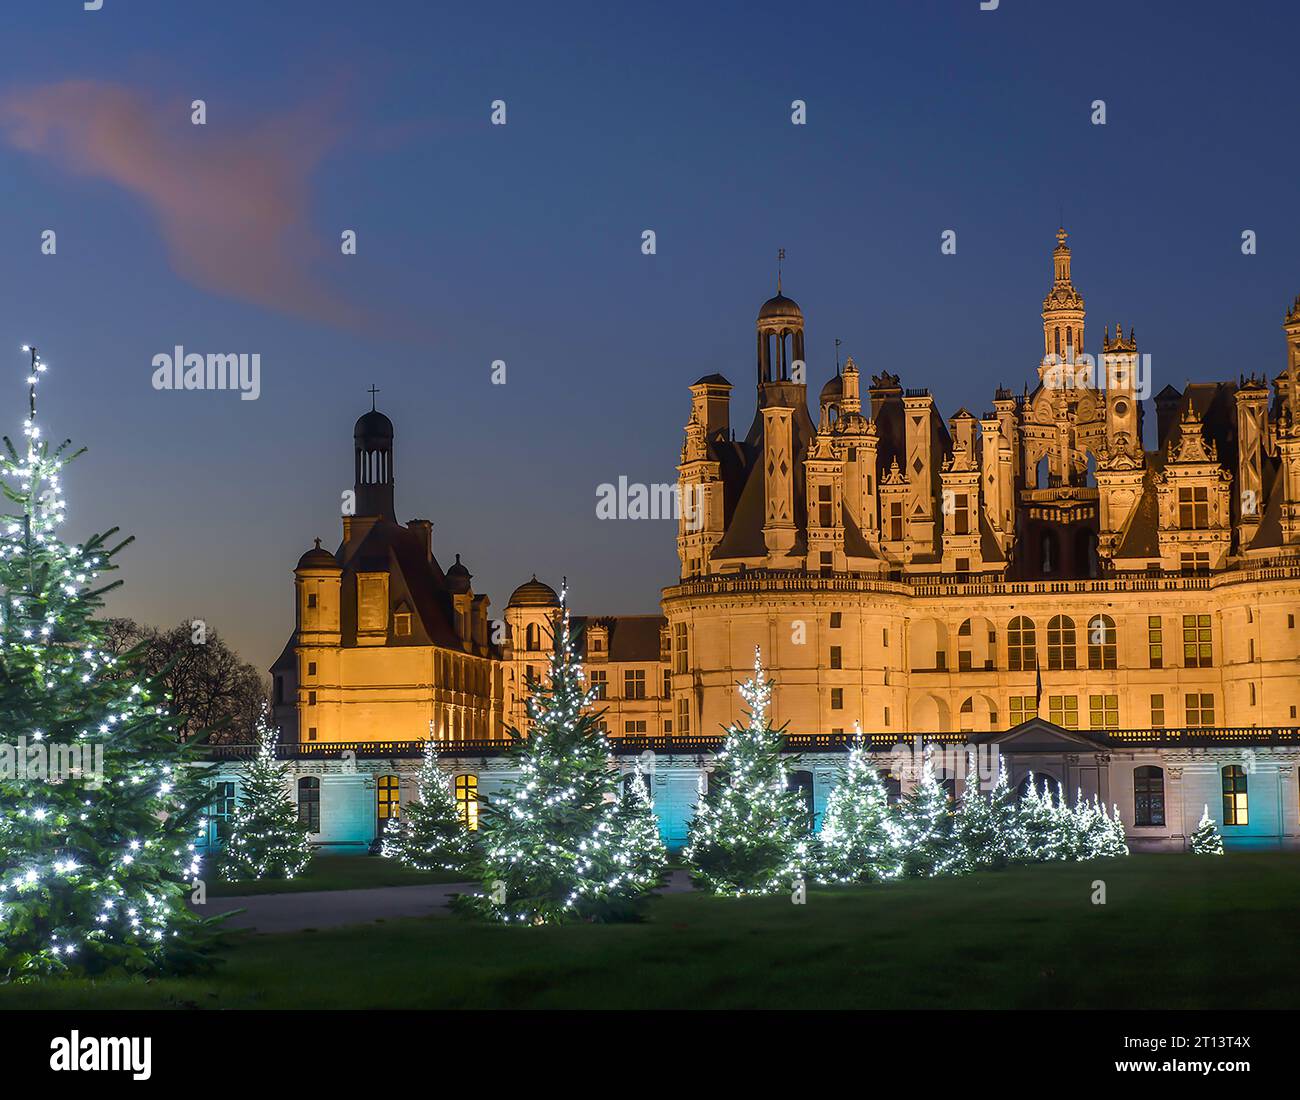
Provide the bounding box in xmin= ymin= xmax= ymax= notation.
xmin=213 ymin=230 xmax=1300 ymax=849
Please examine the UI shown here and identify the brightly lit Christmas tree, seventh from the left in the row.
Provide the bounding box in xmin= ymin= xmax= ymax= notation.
xmin=818 ymin=731 xmax=902 ymax=883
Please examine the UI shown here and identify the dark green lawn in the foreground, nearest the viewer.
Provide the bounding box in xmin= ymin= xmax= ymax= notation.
xmin=10 ymin=853 xmax=1300 ymax=1009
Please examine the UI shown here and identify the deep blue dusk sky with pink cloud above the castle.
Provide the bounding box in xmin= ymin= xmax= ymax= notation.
xmin=0 ymin=0 xmax=1300 ymax=668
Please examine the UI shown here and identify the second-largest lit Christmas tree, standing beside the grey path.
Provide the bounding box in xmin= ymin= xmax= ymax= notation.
xmin=458 ymin=588 xmax=659 ymax=924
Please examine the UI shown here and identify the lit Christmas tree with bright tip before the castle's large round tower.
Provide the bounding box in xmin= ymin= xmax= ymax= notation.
xmin=683 ymin=650 xmax=813 ymax=897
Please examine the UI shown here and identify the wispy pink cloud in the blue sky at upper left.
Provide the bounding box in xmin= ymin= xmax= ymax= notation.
xmin=0 ymin=81 xmax=361 ymax=325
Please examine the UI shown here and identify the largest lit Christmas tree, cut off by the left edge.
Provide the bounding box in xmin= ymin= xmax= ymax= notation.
xmin=0 ymin=348 xmax=211 ymax=980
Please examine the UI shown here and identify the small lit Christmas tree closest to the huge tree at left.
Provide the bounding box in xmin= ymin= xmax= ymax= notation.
xmin=220 ymin=710 xmax=312 ymax=882
